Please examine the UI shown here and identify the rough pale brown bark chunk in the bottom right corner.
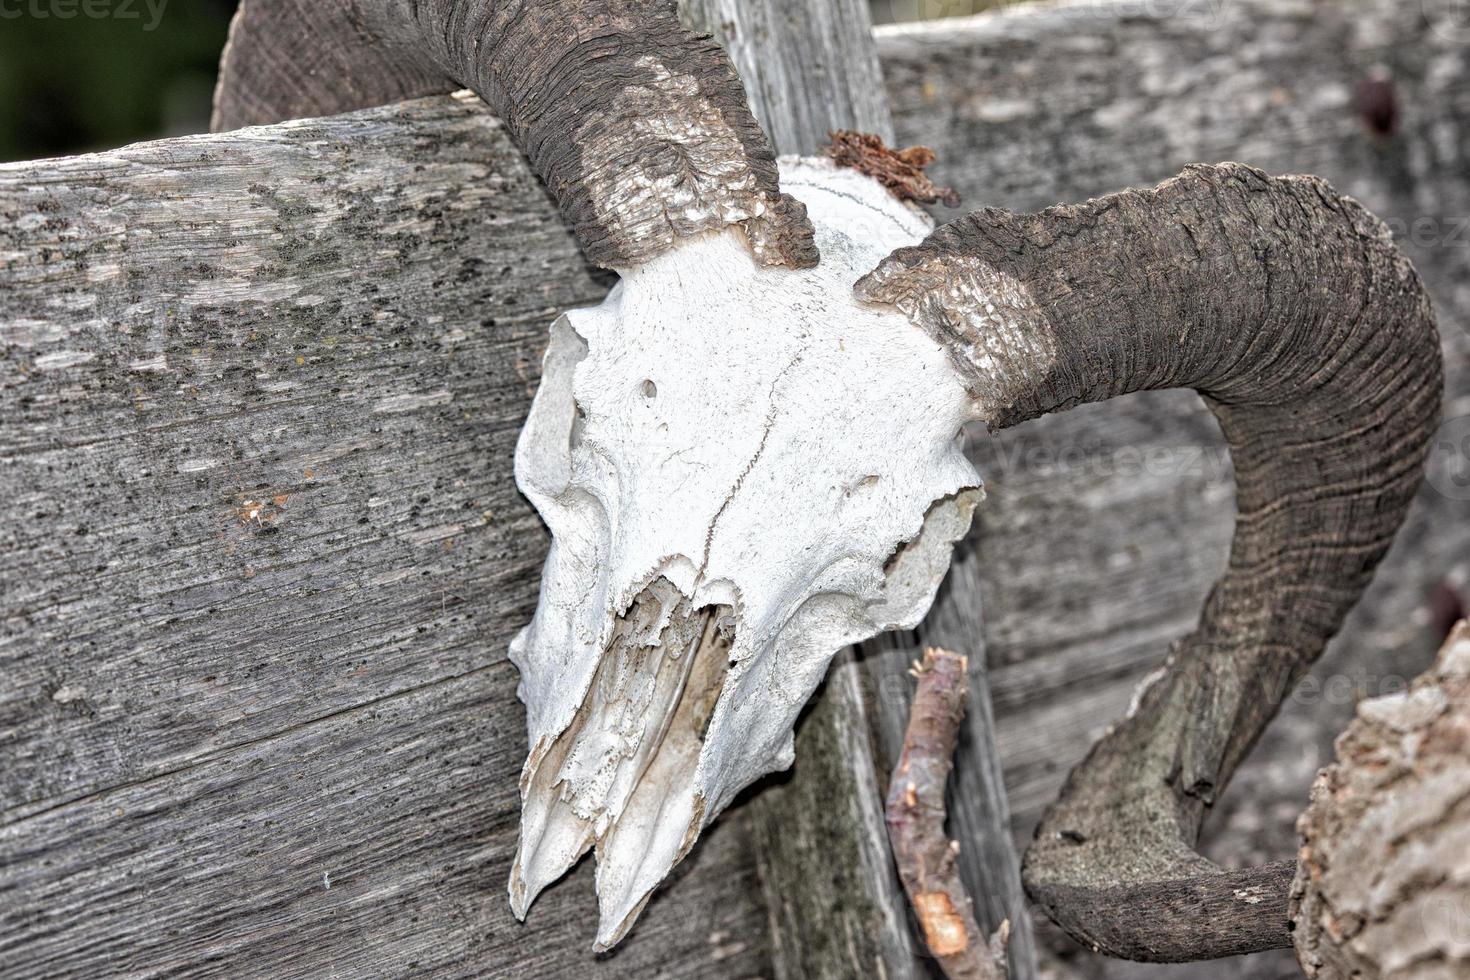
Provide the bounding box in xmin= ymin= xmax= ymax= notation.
xmin=1291 ymin=621 xmax=1470 ymax=980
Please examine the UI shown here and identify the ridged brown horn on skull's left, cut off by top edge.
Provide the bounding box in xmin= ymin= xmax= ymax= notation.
xmin=213 ymin=0 xmax=817 ymax=269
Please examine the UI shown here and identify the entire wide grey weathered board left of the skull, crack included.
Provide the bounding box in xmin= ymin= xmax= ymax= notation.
xmin=0 ymin=97 xmax=767 ymax=977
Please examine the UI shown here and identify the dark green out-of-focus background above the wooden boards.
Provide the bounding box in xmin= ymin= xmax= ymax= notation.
xmin=0 ymin=0 xmax=1001 ymax=162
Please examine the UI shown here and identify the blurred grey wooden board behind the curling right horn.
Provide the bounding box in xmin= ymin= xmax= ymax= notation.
xmin=878 ymin=0 xmax=1470 ymax=979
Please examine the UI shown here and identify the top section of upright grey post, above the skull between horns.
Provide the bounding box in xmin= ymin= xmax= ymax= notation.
xmin=679 ymin=0 xmax=892 ymax=154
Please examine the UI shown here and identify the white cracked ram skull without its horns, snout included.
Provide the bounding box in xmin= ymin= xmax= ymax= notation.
xmin=510 ymin=159 xmax=982 ymax=949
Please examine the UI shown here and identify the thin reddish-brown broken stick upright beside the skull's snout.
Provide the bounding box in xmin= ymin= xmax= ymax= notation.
xmin=886 ymin=646 xmax=1010 ymax=980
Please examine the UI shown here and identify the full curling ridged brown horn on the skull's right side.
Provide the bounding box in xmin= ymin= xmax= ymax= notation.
xmin=857 ymin=165 xmax=1444 ymax=961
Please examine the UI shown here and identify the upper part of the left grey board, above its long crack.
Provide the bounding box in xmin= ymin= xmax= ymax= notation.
xmin=0 ymin=91 xmax=579 ymax=813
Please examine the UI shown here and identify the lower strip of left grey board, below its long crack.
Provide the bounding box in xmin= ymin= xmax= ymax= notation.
xmin=0 ymin=660 xmax=766 ymax=977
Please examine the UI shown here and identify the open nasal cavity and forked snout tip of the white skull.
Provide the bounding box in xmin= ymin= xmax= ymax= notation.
xmin=510 ymin=587 xmax=734 ymax=946
